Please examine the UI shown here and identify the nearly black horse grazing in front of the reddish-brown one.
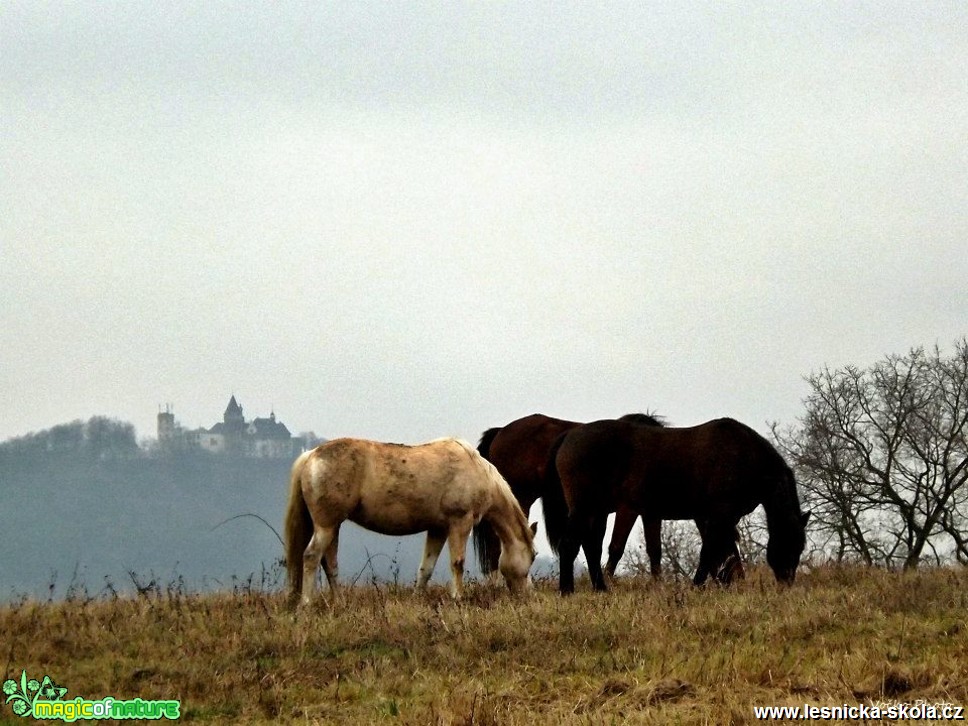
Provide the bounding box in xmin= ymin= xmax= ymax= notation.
xmin=542 ymin=419 xmax=809 ymax=594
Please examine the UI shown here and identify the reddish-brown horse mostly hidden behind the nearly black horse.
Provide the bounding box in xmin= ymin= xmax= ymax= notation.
xmin=474 ymin=413 xmax=728 ymax=577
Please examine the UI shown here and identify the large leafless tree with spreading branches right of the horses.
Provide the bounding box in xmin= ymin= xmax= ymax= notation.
xmin=773 ymin=339 xmax=968 ymax=568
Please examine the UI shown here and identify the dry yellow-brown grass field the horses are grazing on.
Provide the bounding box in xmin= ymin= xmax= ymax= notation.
xmin=0 ymin=566 xmax=968 ymax=726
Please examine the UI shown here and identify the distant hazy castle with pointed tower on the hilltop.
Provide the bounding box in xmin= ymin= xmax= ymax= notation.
xmin=158 ymin=395 xmax=307 ymax=459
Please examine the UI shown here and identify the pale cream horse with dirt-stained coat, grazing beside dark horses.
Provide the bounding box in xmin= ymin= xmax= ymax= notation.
xmin=285 ymin=438 xmax=535 ymax=604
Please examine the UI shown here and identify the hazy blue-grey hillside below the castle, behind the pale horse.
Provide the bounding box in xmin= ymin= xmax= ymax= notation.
xmin=0 ymin=447 xmax=473 ymax=600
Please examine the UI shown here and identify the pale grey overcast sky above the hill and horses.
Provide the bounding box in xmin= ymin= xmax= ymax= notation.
xmin=0 ymin=1 xmax=968 ymax=450
